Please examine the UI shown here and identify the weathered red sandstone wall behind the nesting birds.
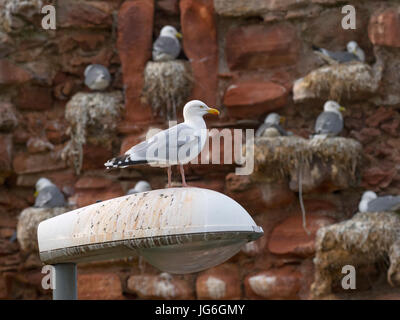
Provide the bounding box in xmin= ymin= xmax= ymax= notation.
xmin=0 ymin=0 xmax=400 ymax=299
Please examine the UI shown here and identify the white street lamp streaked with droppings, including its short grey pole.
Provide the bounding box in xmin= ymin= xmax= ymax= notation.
xmin=38 ymin=188 xmax=263 ymax=299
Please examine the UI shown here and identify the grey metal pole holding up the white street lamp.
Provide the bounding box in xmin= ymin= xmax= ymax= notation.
xmin=53 ymin=263 xmax=78 ymax=300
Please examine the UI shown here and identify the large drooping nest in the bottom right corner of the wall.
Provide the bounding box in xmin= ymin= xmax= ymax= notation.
xmin=311 ymin=212 xmax=400 ymax=298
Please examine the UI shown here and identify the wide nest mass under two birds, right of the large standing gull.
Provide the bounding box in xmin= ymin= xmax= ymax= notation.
xmin=253 ymin=136 xmax=362 ymax=181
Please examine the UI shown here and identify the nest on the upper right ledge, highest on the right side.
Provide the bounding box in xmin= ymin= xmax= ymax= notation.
xmin=293 ymin=62 xmax=381 ymax=102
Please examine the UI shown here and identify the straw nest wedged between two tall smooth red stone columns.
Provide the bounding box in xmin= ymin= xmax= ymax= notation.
xmin=142 ymin=60 xmax=193 ymax=120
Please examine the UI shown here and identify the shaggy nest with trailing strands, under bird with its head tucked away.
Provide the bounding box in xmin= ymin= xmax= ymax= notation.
xmin=62 ymin=91 xmax=124 ymax=175
